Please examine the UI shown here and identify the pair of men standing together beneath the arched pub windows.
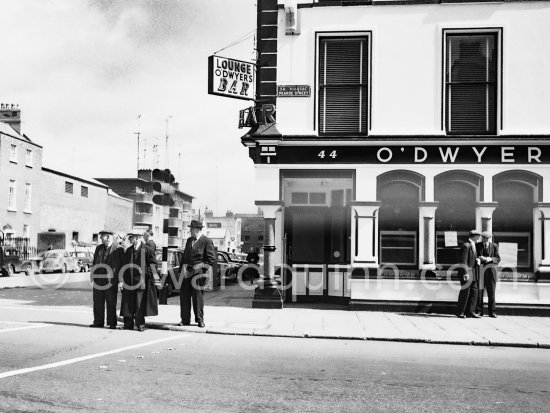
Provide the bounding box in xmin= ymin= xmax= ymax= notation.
xmin=456 ymin=230 xmax=500 ymax=318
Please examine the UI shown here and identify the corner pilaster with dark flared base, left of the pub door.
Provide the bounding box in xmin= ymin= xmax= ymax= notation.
xmin=252 ymin=201 xmax=283 ymax=308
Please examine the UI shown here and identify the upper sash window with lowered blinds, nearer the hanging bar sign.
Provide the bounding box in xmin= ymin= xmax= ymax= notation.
xmin=319 ymin=36 xmax=369 ymax=135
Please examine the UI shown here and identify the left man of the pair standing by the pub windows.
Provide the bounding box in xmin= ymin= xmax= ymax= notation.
xmin=456 ymin=230 xmax=481 ymax=318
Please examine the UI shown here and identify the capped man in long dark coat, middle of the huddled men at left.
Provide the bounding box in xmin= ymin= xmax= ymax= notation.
xmin=120 ymin=232 xmax=158 ymax=331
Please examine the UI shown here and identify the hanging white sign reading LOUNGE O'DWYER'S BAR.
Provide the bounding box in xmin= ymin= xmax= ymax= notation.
xmin=208 ymin=55 xmax=256 ymax=100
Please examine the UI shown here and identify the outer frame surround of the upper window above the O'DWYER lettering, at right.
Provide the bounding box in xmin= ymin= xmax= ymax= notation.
xmin=441 ymin=27 xmax=504 ymax=136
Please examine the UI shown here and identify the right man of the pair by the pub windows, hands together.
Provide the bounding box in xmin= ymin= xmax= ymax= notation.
xmin=477 ymin=232 xmax=500 ymax=318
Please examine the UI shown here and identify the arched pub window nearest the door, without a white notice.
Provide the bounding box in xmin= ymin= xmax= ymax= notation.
xmin=377 ymin=170 xmax=424 ymax=266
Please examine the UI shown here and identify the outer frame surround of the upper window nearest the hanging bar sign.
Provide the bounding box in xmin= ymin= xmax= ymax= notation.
xmin=313 ymin=30 xmax=372 ymax=137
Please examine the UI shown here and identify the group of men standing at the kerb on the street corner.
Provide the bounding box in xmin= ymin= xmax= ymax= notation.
xmin=90 ymin=220 xmax=216 ymax=331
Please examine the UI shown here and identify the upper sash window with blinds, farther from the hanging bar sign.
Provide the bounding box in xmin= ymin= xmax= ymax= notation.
xmin=445 ymin=33 xmax=498 ymax=135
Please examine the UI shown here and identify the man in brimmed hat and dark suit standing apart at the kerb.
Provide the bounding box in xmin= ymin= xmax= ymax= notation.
xmin=178 ymin=220 xmax=216 ymax=327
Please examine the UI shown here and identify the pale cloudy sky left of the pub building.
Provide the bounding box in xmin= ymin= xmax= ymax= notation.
xmin=0 ymin=0 xmax=256 ymax=215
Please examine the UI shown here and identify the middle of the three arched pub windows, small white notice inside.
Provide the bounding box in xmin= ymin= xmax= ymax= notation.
xmin=435 ymin=170 xmax=483 ymax=265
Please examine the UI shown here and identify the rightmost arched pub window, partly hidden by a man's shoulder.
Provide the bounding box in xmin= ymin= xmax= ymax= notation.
xmin=493 ymin=171 xmax=542 ymax=270
